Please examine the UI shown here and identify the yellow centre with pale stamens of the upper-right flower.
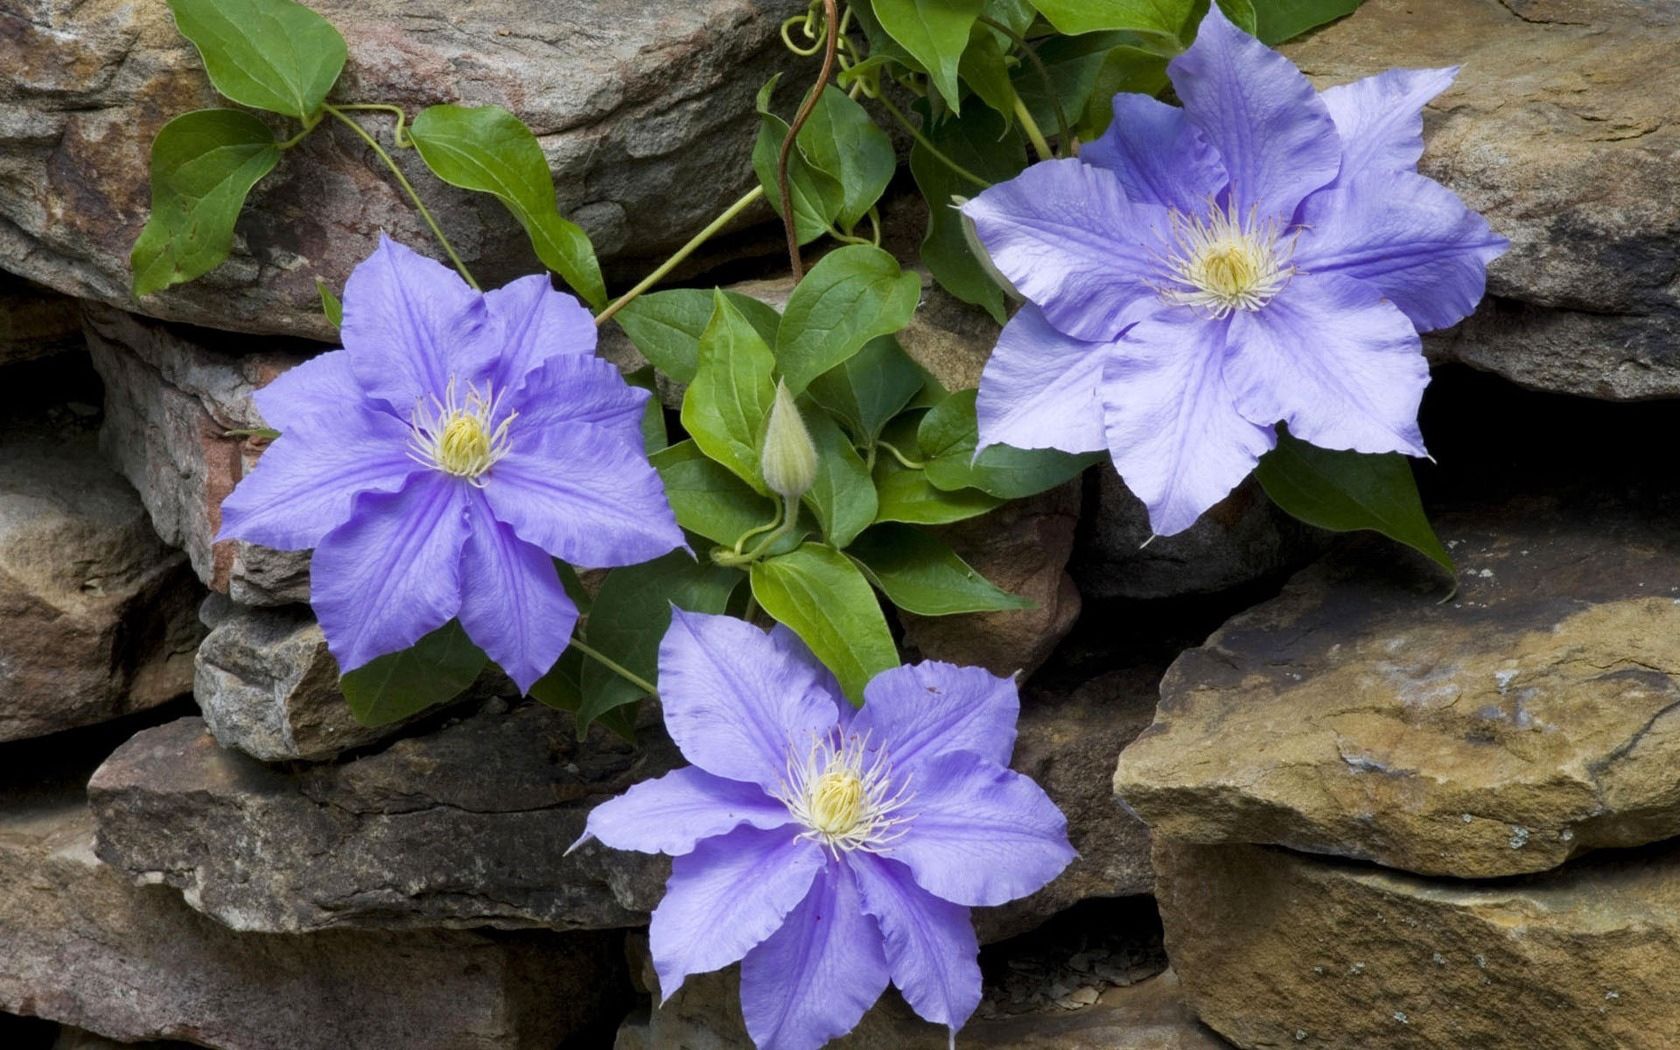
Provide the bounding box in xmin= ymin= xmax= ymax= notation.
xmin=1161 ymin=202 xmax=1295 ymax=318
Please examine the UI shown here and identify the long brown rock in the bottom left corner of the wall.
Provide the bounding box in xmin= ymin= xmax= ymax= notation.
xmin=0 ymin=793 xmax=612 ymax=1050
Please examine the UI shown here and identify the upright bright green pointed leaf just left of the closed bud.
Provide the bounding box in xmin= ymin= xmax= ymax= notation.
xmin=682 ymin=292 xmax=776 ymax=492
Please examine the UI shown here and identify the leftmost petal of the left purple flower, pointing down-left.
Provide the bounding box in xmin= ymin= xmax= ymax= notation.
xmin=217 ymin=409 xmax=423 ymax=551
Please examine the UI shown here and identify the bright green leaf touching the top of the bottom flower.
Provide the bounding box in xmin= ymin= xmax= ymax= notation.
xmin=751 ymin=543 xmax=899 ymax=704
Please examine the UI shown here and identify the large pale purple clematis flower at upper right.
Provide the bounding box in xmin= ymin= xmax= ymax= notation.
xmin=963 ymin=3 xmax=1507 ymax=536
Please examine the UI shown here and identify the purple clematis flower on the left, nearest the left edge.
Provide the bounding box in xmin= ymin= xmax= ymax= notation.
xmin=218 ymin=237 xmax=682 ymax=689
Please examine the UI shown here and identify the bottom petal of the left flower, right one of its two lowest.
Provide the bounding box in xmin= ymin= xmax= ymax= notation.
xmin=460 ymin=489 xmax=578 ymax=692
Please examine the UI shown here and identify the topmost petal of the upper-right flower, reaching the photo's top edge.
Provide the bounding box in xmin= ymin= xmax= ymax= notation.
xmin=1166 ymin=3 xmax=1342 ymax=220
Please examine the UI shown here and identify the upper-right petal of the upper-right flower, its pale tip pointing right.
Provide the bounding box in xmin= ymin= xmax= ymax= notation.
xmin=1319 ymin=66 xmax=1458 ymax=183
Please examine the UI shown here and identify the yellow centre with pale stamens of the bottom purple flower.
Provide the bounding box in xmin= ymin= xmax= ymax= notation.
xmin=776 ymin=732 xmax=911 ymax=855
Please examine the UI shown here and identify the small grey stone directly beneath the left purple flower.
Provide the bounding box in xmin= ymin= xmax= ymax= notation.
xmin=193 ymin=595 xmax=482 ymax=763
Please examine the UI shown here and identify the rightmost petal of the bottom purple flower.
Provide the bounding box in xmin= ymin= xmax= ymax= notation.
xmin=890 ymin=751 xmax=1077 ymax=907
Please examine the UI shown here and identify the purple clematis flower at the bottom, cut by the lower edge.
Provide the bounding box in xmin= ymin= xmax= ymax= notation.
xmin=573 ymin=608 xmax=1074 ymax=1050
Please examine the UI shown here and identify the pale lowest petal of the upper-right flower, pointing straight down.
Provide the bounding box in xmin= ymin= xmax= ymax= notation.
xmin=1102 ymin=307 xmax=1277 ymax=536
